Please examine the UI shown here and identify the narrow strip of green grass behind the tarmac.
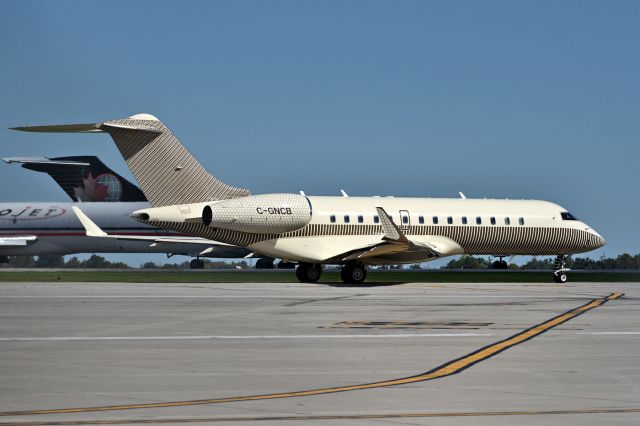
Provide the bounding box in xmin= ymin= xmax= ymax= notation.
xmin=0 ymin=270 xmax=640 ymax=284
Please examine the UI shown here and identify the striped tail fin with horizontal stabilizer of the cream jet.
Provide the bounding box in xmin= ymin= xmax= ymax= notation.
xmin=13 ymin=114 xmax=249 ymax=207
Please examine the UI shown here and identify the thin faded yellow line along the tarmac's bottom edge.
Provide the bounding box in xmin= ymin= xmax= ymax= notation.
xmin=0 ymin=407 xmax=640 ymax=426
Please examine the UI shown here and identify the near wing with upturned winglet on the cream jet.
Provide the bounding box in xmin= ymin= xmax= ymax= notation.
xmin=327 ymin=207 xmax=463 ymax=264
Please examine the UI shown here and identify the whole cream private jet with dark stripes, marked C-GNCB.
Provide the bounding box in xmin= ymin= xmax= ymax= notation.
xmin=14 ymin=114 xmax=605 ymax=283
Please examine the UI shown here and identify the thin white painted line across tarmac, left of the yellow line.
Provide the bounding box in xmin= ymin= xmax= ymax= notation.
xmin=0 ymin=333 xmax=491 ymax=342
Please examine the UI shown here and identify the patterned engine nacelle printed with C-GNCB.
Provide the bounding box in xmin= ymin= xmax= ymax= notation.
xmin=202 ymin=194 xmax=311 ymax=234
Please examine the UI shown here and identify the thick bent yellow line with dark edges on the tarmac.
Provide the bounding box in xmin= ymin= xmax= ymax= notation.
xmin=0 ymin=292 xmax=624 ymax=417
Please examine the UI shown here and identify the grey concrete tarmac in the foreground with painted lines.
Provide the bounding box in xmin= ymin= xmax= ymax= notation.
xmin=0 ymin=283 xmax=640 ymax=425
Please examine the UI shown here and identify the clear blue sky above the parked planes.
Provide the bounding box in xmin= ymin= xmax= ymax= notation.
xmin=0 ymin=0 xmax=640 ymax=259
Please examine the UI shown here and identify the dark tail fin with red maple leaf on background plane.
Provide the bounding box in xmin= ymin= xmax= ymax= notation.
xmin=3 ymin=155 xmax=147 ymax=202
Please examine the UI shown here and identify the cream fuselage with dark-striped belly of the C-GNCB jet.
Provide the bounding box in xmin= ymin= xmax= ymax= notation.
xmin=135 ymin=194 xmax=604 ymax=264
